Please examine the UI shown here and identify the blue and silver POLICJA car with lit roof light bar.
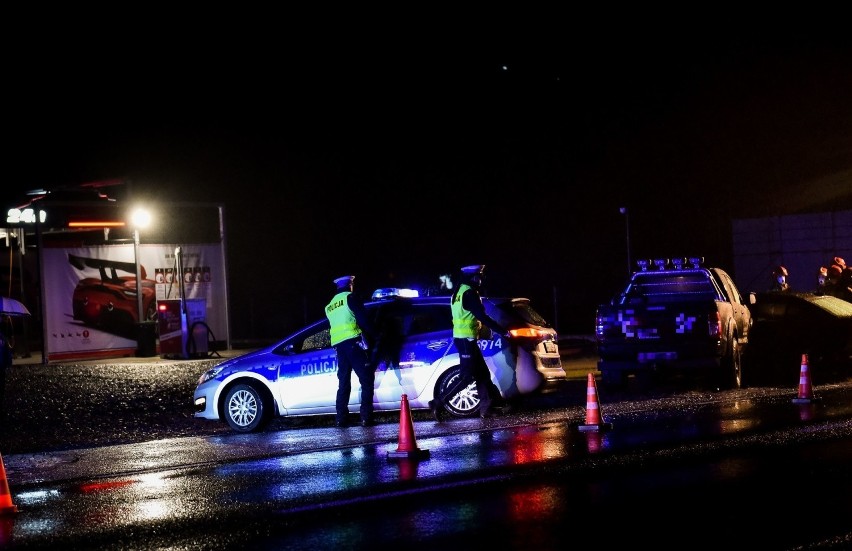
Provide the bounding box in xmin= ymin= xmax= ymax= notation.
xmin=194 ymin=289 xmax=565 ymax=432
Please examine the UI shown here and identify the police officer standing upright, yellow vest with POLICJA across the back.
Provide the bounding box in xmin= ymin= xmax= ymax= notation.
xmin=325 ymin=276 xmax=376 ymax=427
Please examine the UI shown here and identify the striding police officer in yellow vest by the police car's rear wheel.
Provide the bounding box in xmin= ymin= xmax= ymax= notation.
xmin=429 ymin=264 xmax=508 ymax=421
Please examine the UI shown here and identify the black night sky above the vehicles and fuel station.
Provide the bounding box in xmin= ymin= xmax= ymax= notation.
xmin=3 ymin=19 xmax=852 ymax=334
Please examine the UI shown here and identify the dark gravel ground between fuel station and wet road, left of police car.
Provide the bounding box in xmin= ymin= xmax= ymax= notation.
xmin=0 ymin=351 xmax=236 ymax=455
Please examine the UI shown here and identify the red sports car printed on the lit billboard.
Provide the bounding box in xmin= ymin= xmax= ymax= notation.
xmin=68 ymin=254 xmax=157 ymax=336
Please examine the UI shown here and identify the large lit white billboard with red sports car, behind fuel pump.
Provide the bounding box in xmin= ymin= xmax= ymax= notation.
xmin=42 ymin=243 xmax=229 ymax=361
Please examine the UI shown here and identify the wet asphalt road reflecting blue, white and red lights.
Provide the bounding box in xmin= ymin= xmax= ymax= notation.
xmin=6 ymin=383 xmax=852 ymax=549
